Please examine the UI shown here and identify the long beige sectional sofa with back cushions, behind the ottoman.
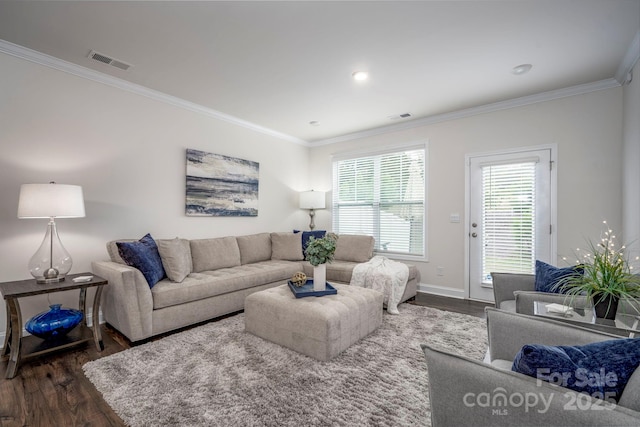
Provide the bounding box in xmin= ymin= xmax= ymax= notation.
xmin=92 ymin=233 xmax=420 ymax=341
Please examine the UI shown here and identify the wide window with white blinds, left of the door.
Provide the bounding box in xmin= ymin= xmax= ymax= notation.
xmin=333 ymin=145 xmax=426 ymax=257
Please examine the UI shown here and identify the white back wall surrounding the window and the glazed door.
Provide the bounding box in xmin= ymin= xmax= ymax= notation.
xmin=310 ymin=88 xmax=622 ymax=295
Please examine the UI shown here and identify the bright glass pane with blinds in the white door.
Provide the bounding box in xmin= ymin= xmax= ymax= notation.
xmin=482 ymin=161 xmax=536 ymax=282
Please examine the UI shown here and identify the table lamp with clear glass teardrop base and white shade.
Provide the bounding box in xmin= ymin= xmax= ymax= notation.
xmin=18 ymin=182 xmax=84 ymax=283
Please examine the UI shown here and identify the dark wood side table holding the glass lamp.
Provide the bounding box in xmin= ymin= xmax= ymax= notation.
xmin=0 ymin=273 xmax=109 ymax=379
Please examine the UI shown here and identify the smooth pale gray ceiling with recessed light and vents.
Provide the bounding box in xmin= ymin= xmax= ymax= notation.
xmin=0 ymin=0 xmax=640 ymax=142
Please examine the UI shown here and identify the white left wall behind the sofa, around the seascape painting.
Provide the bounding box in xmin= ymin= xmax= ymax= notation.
xmin=0 ymin=54 xmax=310 ymax=334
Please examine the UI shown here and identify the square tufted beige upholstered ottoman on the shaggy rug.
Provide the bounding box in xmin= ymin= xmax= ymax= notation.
xmin=244 ymin=284 xmax=383 ymax=361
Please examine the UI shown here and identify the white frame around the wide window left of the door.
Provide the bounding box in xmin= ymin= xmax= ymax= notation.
xmin=331 ymin=141 xmax=429 ymax=262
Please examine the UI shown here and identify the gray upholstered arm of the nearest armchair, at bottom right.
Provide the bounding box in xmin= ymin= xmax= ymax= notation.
xmin=422 ymin=345 xmax=640 ymax=427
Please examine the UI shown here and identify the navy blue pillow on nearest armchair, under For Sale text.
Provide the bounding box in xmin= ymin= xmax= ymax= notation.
xmin=511 ymin=338 xmax=640 ymax=402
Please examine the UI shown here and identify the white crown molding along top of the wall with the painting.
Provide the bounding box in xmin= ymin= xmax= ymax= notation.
xmin=0 ymin=39 xmax=309 ymax=146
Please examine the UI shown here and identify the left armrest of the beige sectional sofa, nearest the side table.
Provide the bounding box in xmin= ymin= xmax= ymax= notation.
xmin=91 ymin=261 xmax=153 ymax=341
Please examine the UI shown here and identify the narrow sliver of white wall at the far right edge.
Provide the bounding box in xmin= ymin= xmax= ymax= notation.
xmin=623 ymin=62 xmax=640 ymax=268
